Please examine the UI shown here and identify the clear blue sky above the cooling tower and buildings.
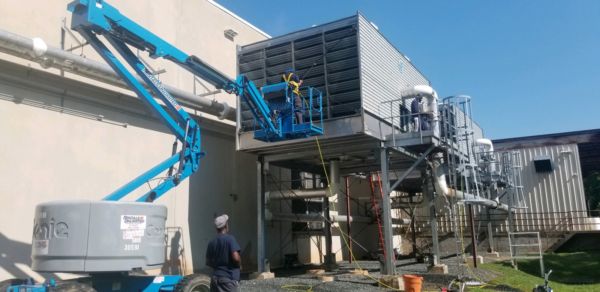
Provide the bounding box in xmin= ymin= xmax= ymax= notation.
xmin=218 ymin=0 xmax=600 ymax=139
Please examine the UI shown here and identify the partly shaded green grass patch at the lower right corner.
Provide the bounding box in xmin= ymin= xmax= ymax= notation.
xmin=469 ymin=252 xmax=600 ymax=292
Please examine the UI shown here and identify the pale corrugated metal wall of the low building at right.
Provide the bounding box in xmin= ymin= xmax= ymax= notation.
xmin=408 ymin=144 xmax=590 ymax=237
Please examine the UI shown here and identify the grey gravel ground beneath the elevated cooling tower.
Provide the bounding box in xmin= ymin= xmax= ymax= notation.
xmin=240 ymin=257 xmax=502 ymax=292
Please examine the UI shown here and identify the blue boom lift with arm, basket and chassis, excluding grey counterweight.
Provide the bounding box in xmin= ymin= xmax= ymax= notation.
xmin=0 ymin=0 xmax=323 ymax=292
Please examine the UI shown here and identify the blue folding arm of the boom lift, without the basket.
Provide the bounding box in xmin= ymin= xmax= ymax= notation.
xmin=68 ymin=0 xmax=281 ymax=202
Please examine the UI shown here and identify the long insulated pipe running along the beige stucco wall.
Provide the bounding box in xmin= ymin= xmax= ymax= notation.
xmin=0 ymin=29 xmax=235 ymax=121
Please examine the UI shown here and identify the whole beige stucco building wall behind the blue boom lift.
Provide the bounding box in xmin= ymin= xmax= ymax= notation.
xmin=0 ymin=0 xmax=266 ymax=280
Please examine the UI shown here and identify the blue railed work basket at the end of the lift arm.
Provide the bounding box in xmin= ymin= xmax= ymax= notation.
xmin=249 ymin=82 xmax=323 ymax=142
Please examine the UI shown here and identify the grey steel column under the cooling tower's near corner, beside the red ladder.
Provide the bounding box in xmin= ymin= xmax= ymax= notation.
xmin=380 ymin=147 xmax=396 ymax=275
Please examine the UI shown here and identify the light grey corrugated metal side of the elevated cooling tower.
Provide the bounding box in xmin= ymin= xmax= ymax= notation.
xmin=358 ymin=14 xmax=430 ymax=121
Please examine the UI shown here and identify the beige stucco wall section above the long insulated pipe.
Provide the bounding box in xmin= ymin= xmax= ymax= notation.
xmin=0 ymin=0 xmax=267 ymax=112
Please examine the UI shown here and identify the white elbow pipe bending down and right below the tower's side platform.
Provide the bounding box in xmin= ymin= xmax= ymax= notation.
xmin=433 ymin=156 xmax=508 ymax=212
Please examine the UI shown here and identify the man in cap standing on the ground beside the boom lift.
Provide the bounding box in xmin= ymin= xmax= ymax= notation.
xmin=206 ymin=214 xmax=242 ymax=292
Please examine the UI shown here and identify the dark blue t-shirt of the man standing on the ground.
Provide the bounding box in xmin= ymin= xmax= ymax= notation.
xmin=206 ymin=234 xmax=241 ymax=281
